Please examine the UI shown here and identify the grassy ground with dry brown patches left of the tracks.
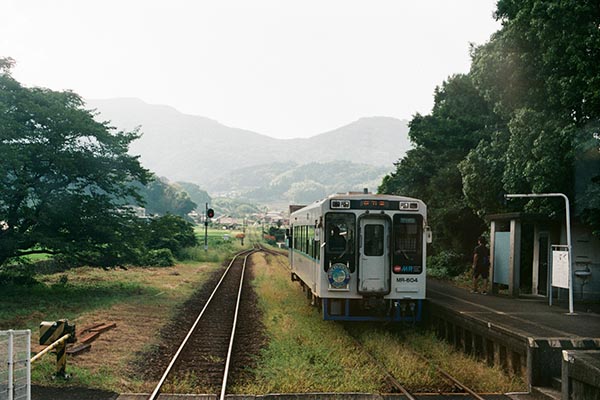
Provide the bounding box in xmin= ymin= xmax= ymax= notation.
xmin=0 ymin=230 xmax=246 ymax=392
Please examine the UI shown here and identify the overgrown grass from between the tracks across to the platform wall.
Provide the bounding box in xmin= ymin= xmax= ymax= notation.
xmin=233 ymin=252 xmax=525 ymax=394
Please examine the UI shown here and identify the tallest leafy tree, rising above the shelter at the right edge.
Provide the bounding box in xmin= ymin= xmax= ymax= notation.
xmin=468 ymin=0 xmax=600 ymax=229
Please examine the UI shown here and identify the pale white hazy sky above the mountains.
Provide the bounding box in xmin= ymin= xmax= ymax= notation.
xmin=0 ymin=0 xmax=500 ymax=138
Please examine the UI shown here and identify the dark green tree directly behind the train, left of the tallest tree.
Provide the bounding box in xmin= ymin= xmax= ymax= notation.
xmin=379 ymin=75 xmax=497 ymax=254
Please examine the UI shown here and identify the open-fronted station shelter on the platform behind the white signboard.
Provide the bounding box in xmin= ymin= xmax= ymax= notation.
xmin=486 ymin=212 xmax=600 ymax=303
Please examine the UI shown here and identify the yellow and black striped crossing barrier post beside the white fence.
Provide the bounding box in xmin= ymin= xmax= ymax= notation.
xmin=31 ymin=319 xmax=77 ymax=378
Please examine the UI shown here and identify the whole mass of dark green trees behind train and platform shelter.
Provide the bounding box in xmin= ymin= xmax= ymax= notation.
xmin=379 ymin=0 xmax=600 ymax=256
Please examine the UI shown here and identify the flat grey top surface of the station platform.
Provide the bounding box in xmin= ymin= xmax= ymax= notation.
xmin=427 ymin=279 xmax=600 ymax=340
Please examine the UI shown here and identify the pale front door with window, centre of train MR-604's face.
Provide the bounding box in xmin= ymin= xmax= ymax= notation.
xmin=358 ymin=217 xmax=390 ymax=294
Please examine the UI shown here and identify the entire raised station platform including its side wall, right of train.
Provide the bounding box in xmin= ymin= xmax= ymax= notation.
xmin=425 ymin=279 xmax=600 ymax=394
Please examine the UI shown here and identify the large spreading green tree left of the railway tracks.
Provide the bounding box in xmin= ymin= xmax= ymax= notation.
xmin=0 ymin=58 xmax=149 ymax=266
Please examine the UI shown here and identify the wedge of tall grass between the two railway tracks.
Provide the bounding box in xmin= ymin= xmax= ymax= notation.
xmin=232 ymin=255 xmax=380 ymax=393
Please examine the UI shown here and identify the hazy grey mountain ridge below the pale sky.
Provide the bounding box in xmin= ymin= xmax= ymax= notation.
xmin=87 ymin=98 xmax=410 ymax=203
